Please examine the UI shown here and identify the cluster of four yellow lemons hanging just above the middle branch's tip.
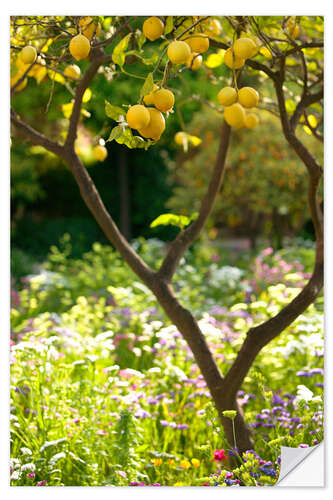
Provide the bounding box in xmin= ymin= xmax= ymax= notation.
xmin=217 ymin=87 xmax=259 ymax=129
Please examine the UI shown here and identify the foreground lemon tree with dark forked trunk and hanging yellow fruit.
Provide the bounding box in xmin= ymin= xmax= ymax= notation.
xmin=11 ymin=16 xmax=323 ymax=451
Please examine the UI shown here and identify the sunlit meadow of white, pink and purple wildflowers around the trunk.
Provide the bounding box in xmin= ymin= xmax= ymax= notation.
xmin=11 ymin=236 xmax=323 ymax=486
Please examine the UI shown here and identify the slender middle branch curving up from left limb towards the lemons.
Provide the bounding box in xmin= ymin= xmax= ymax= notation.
xmin=157 ymin=121 xmax=230 ymax=282
